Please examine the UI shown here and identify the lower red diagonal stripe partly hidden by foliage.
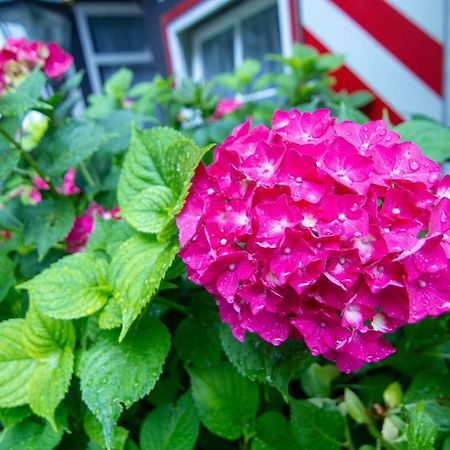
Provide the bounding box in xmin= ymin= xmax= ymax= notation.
xmin=303 ymin=28 xmax=403 ymax=125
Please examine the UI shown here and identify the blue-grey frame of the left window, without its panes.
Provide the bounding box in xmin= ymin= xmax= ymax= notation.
xmin=74 ymin=2 xmax=154 ymax=94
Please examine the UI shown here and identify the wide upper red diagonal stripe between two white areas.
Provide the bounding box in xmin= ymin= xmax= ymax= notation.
xmin=332 ymin=0 xmax=444 ymax=95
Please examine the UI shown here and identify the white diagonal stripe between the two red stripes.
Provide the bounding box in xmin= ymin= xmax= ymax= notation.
xmin=300 ymin=0 xmax=443 ymax=120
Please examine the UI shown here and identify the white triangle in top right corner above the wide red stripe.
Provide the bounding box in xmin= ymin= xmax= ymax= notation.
xmin=387 ymin=0 xmax=445 ymax=44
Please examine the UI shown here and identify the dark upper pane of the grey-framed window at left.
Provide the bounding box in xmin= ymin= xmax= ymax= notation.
xmin=88 ymin=17 xmax=148 ymax=53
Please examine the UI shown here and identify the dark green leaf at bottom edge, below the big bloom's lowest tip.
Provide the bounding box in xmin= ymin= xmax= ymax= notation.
xmin=291 ymin=400 xmax=345 ymax=450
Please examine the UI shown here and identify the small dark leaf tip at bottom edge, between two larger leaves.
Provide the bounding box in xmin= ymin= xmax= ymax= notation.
xmin=252 ymin=411 xmax=301 ymax=450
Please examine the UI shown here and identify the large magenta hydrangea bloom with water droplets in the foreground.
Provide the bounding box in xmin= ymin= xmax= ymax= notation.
xmin=177 ymin=110 xmax=450 ymax=373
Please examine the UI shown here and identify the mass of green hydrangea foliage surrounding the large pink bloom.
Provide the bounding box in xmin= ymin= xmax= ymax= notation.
xmin=0 ymin=39 xmax=450 ymax=450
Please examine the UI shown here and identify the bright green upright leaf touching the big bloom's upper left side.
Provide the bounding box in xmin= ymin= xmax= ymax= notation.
xmin=117 ymin=128 xmax=207 ymax=233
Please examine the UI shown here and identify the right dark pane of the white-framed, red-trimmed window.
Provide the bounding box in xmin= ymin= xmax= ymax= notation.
xmin=242 ymin=5 xmax=281 ymax=73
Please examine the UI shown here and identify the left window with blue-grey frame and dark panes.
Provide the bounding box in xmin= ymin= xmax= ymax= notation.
xmin=75 ymin=3 xmax=154 ymax=93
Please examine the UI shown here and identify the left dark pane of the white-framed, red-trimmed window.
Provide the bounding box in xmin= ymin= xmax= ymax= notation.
xmin=202 ymin=29 xmax=234 ymax=80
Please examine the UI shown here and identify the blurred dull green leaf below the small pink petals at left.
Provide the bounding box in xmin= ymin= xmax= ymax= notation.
xmin=25 ymin=197 xmax=75 ymax=260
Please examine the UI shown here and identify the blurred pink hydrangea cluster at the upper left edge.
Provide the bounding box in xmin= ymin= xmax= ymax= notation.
xmin=0 ymin=38 xmax=73 ymax=95
